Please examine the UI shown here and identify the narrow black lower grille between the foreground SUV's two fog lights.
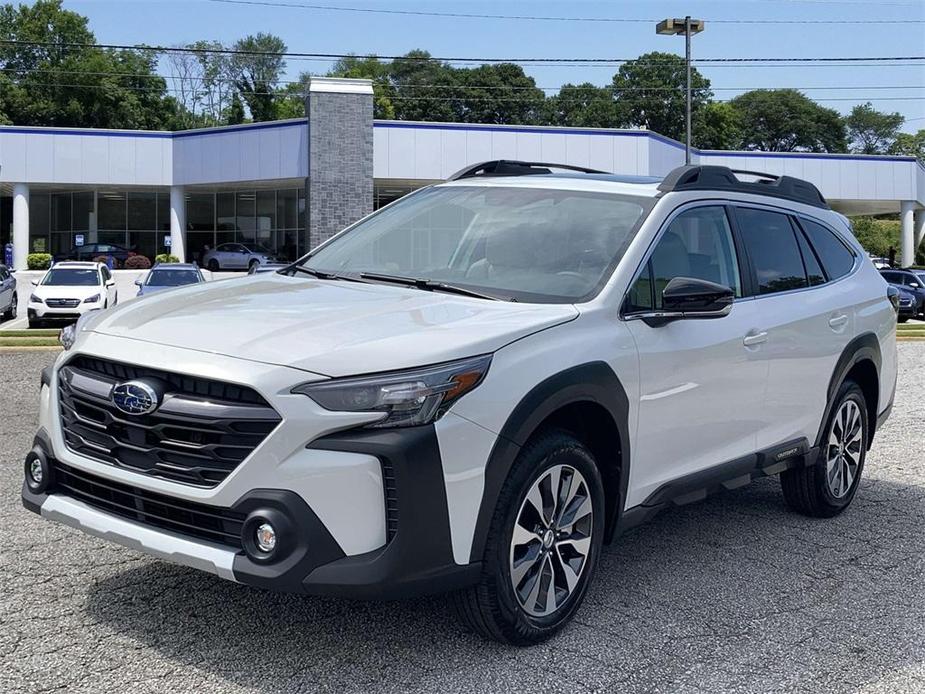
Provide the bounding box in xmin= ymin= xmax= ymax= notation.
xmin=52 ymin=461 xmax=245 ymax=550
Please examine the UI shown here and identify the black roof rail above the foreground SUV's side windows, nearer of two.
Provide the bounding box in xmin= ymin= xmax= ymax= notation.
xmin=658 ymin=165 xmax=830 ymax=210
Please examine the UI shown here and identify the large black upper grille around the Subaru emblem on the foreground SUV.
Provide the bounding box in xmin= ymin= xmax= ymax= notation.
xmin=58 ymin=356 xmax=280 ymax=487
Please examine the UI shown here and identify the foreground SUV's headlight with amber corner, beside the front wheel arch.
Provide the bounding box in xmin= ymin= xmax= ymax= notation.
xmin=292 ymin=355 xmax=491 ymax=427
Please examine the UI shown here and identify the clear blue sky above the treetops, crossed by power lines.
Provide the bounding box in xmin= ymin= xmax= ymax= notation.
xmin=64 ymin=0 xmax=925 ymax=132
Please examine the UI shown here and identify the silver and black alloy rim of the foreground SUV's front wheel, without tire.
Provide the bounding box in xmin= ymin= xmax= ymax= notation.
xmin=510 ymin=465 xmax=594 ymax=617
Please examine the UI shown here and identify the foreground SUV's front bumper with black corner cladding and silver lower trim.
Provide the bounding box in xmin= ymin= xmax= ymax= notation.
xmin=22 ymin=371 xmax=480 ymax=599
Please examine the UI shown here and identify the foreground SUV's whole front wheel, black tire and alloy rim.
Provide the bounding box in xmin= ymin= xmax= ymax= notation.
xmin=454 ymin=430 xmax=604 ymax=646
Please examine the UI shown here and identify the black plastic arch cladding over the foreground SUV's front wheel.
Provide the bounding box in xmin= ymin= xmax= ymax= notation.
xmin=470 ymin=361 xmax=630 ymax=561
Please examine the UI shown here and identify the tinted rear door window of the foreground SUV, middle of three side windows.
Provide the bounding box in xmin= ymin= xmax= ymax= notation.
xmin=736 ymin=207 xmax=809 ymax=294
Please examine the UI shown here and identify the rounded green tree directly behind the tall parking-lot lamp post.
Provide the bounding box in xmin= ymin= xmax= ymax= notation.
xmin=612 ymin=52 xmax=713 ymax=140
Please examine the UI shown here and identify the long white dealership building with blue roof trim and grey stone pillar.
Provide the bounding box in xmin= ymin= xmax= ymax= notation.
xmin=0 ymin=78 xmax=925 ymax=269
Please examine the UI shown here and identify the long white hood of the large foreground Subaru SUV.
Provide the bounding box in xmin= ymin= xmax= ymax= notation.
xmin=88 ymin=274 xmax=578 ymax=376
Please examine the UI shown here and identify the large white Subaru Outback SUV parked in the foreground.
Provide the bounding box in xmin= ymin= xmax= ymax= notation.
xmin=22 ymin=161 xmax=896 ymax=644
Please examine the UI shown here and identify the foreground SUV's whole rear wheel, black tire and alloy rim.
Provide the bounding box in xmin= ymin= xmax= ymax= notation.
xmin=780 ymin=381 xmax=870 ymax=518
